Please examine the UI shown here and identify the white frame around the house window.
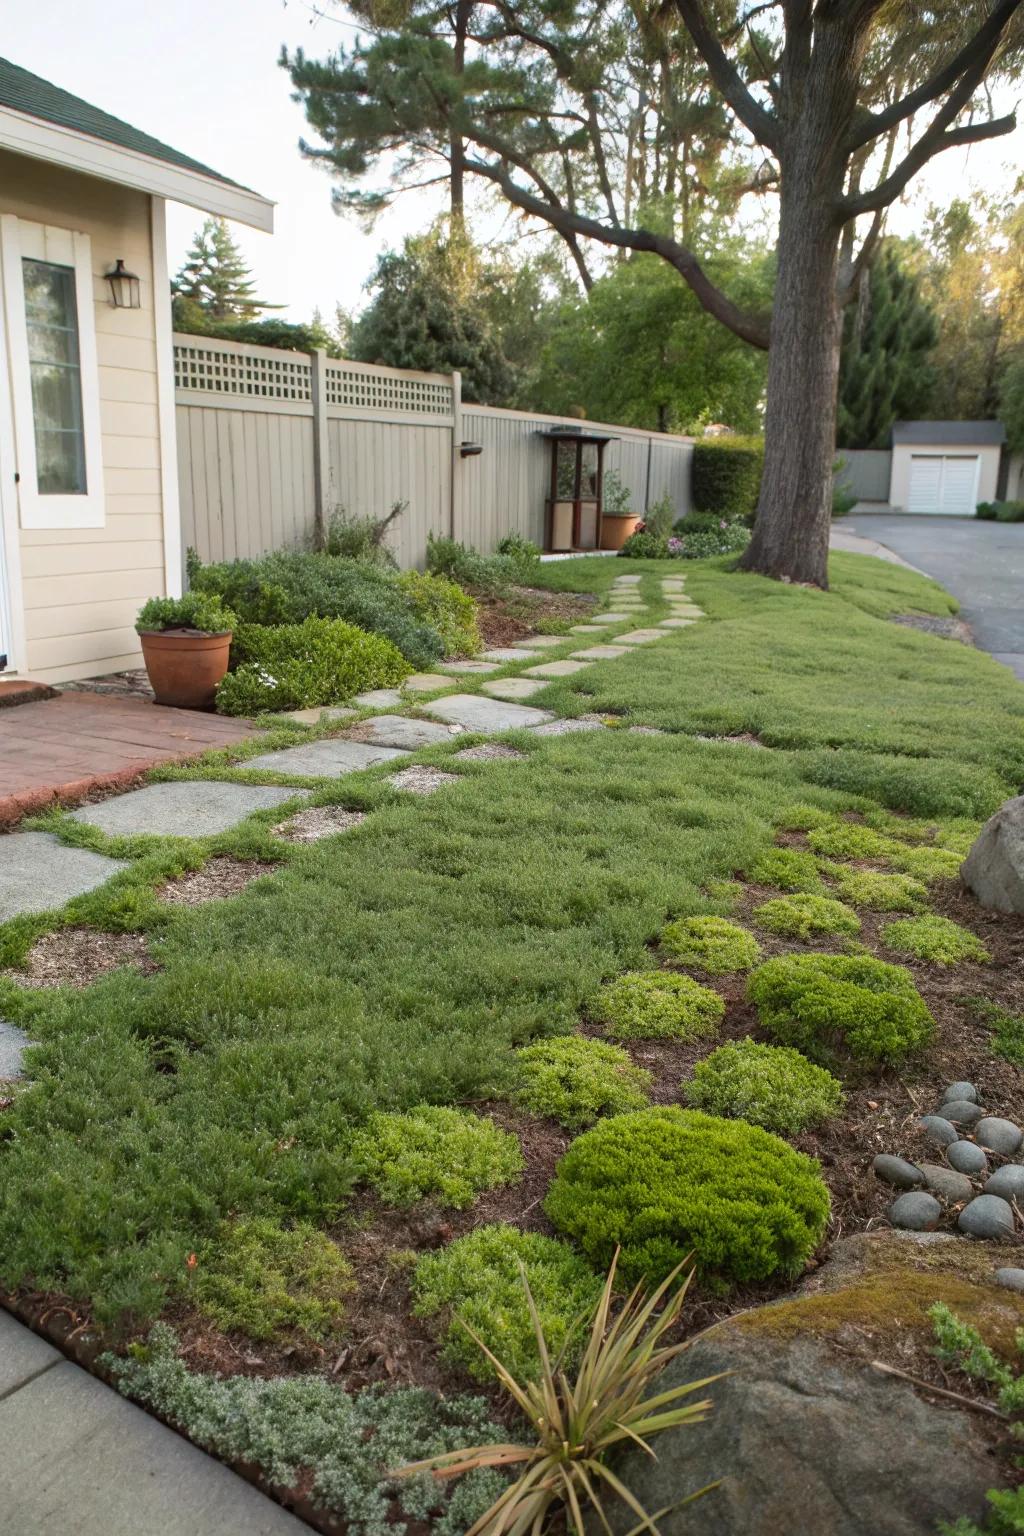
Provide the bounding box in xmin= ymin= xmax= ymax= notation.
xmin=0 ymin=214 xmax=106 ymax=528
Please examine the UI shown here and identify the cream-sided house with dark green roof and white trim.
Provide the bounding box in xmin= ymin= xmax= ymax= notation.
xmin=0 ymin=60 xmax=273 ymax=682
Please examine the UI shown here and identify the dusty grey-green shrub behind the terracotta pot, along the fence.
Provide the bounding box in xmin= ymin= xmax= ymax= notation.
xmin=190 ymin=550 xmax=444 ymax=667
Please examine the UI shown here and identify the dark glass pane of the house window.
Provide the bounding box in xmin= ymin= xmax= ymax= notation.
xmin=21 ymin=261 xmax=86 ymax=496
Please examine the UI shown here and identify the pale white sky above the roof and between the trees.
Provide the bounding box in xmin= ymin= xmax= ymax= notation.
xmin=0 ymin=0 xmax=1024 ymax=319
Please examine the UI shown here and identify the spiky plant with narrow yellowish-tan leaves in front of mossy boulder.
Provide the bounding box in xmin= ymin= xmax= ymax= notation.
xmin=391 ymin=1250 xmax=720 ymax=1536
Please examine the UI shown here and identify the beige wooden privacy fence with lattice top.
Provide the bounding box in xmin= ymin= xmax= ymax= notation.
xmin=173 ymin=335 xmax=692 ymax=565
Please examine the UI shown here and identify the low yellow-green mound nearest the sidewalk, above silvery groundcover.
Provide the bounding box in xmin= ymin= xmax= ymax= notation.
xmin=192 ymin=1217 xmax=353 ymax=1339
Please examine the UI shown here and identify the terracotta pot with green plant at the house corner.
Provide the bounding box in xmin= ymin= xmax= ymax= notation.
xmin=135 ymin=591 xmax=236 ymax=710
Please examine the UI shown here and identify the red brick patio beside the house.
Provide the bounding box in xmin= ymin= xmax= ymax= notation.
xmin=0 ymin=693 xmax=253 ymax=826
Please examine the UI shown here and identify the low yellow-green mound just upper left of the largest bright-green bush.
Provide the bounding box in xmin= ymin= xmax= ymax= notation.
xmin=513 ymin=1035 xmax=651 ymax=1130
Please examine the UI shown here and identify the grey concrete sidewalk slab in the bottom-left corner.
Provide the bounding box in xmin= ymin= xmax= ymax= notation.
xmin=0 ymin=1310 xmax=309 ymax=1536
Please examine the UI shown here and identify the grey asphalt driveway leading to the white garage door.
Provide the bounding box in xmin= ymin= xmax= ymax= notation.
xmin=838 ymin=511 xmax=1024 ymax=682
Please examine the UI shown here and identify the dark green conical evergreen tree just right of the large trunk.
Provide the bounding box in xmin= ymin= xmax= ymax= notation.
xmin=837 ymin=244 xmax=938 ymax=449
